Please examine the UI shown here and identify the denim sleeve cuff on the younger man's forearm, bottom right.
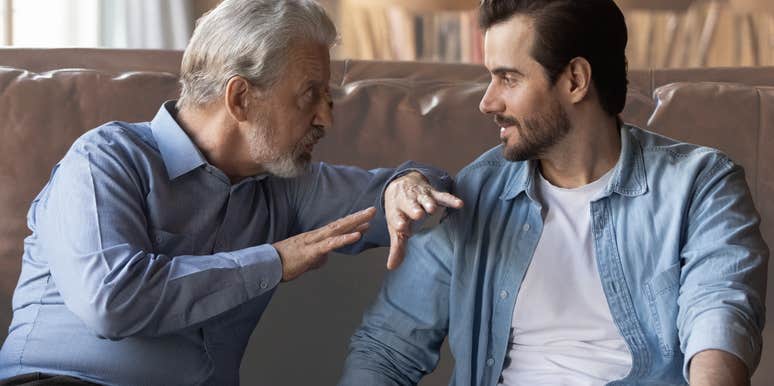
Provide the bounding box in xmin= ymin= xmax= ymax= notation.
xmin=683 ymin=313 xmax=761 ymax=381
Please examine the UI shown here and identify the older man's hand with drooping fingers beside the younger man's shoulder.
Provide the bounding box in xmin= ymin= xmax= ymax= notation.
xmin=384 ymin=172 xmax=462 ymax=269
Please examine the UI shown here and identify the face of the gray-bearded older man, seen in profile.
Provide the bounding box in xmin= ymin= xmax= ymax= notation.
xmin=248 ymin=42 xmax=333 ymax=177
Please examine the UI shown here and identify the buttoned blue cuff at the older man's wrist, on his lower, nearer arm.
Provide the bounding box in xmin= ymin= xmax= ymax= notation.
xmin=229 ymin=244 xmax=282 ymax=298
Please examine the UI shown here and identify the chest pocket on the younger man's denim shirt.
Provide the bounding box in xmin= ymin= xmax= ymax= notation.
xmin=645 ymin=263 xmax=680 ymax=358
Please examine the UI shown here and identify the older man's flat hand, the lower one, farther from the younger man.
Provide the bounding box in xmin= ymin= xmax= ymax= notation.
xmin=272 ymin=207 xmax=376 ymax=281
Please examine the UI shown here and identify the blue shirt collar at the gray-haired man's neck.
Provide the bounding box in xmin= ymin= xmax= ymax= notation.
xmin=151 ymin=101 xmax=207 ymax=180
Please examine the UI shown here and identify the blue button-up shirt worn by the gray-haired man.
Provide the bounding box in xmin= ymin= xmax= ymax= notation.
xmin=0 ymin=102 xmax=451 ymax=385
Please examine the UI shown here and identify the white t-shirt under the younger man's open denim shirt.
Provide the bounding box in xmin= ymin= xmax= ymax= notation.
xmin=500 ymin=170 xmax=632 ymax=386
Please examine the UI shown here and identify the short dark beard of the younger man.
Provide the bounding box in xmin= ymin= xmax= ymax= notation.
xmin=495 ymin=101 xmax=570 ymax=162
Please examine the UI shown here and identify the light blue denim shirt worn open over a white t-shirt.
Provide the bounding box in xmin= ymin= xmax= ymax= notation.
xmin=341 ymin=126 xmax=769 ymax=386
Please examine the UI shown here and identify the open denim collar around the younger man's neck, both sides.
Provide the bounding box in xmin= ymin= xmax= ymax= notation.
xmin=500 ymin=124 xmax=648 ymax=202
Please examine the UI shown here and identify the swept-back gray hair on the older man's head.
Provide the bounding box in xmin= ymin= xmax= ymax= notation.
xmin=177 ymin=0 xmax=338 ymax=109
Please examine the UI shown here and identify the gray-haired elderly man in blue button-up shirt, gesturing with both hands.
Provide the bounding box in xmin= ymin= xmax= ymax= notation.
xmin=0 ymin=0 xmax=461 ymax=385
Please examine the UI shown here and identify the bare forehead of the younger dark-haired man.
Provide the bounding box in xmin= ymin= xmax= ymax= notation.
xmin=484 ymin=15 xmax=535 ymax=71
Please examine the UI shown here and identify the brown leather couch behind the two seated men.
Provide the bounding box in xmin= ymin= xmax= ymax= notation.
xmin=0 ymin=49 xmax=774 ymax=385
